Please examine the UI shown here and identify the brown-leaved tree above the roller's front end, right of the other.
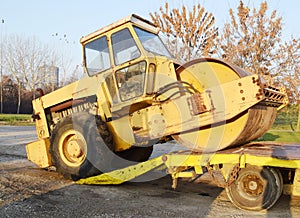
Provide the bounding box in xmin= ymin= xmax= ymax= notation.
xmin=218 ymin=1 xmax=298 ymax=80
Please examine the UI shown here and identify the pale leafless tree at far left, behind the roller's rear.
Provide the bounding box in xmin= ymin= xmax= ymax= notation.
xmin=4 ymin=35 xmax=55 ymax=113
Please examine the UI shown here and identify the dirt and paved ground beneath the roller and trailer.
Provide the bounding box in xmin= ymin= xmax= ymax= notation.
xmin=0 ymin=126 xmax=300 ymax=217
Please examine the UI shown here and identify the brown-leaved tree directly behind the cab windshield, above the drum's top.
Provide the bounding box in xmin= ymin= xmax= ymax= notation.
xmin=150 ymin=3 xmax=218 ymax=61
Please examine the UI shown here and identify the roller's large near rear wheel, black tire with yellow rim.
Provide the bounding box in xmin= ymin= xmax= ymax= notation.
xmin=50 ymin=112 xmax=113 ymax=180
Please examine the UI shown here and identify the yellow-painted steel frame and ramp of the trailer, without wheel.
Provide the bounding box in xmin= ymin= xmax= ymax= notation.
xmin=76 ymin=153 xmax=300 ymax=190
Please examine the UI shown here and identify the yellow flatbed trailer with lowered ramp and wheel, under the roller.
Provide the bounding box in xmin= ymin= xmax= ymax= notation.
xmin=76 ymin=142 xmax=300 ymax=211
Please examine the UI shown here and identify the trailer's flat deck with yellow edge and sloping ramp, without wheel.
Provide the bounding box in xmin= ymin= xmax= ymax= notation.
xmin=76 ymin=142 xmax=300 ymax=185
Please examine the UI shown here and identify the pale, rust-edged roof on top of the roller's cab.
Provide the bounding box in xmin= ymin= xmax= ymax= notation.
xmin=80 ymin=14 xmax=159 ymax=44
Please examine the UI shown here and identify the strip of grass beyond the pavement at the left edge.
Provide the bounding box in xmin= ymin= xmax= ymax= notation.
xmin=0 ymin=114 xmax=34 ymax=126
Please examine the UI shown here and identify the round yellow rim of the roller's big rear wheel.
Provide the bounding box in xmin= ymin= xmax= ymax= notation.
xmin=58 ymin=130 xmax=87 ymax=167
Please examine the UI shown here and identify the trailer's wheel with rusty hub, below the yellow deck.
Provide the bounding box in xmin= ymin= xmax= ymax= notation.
xmin=226 ymin=165 xmax=283 ymax=211
